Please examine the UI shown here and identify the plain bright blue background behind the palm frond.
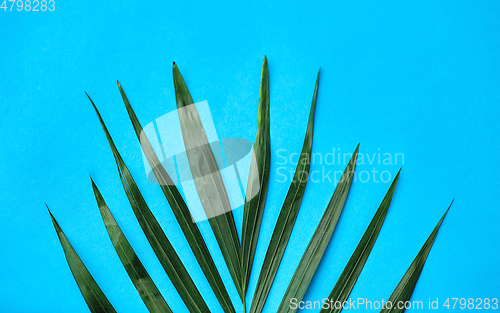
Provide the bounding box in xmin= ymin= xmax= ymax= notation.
xmin=0 ymin=0 xmax=500 ymax=312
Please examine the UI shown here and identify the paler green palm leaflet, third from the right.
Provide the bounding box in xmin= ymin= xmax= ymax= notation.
xmin=278 ymin=144 xmax=359 ymax=313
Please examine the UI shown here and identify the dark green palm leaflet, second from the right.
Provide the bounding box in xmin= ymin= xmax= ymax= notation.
xmin=320 ymin=170 xmax=401 ymax=313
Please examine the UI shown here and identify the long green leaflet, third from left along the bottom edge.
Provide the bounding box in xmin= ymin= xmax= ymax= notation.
xmin=89 ymin=97 xmax=210 ymax=313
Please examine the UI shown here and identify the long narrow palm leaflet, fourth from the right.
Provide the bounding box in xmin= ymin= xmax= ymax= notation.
xmin=250 ymin=72 xmax=319 ymax=313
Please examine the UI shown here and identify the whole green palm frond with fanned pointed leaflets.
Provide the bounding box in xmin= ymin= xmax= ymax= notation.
xmin=49 ymin=57 xmax=453 ymax=313
